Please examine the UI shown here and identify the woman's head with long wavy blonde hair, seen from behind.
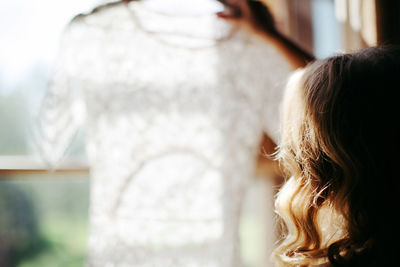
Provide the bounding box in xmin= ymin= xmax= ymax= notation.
xmin=275 ymin=47 xmax=400 ymax=266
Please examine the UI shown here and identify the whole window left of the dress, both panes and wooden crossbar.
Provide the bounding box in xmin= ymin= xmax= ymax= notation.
xmin=0 ymin=0 xmax=96 ymax=267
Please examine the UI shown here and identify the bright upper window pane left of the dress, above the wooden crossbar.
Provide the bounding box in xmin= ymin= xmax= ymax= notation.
xmin=0 ymin=0 xmax=104 ymax=155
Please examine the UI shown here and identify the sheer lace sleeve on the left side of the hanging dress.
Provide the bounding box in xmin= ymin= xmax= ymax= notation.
xmin=37 ymin=21 xmax=85 ymax=168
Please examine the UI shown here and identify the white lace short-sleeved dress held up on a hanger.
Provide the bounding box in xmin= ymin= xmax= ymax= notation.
xmin=40 ymin=2 xmax=291 ymax=267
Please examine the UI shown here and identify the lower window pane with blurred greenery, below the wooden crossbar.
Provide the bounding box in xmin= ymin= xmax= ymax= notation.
xmin=0 ymin=173 xmax=89 ymax=267
